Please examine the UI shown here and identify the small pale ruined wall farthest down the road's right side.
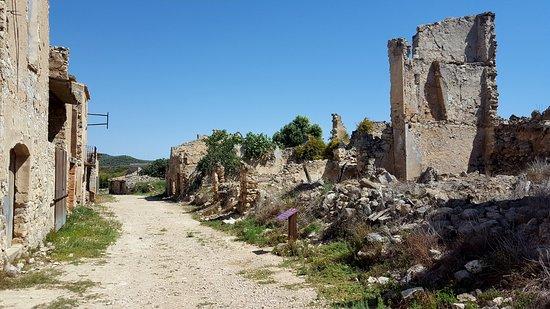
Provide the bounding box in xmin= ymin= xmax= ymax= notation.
xmin=166 ymin=138 xmax=207 ymax=197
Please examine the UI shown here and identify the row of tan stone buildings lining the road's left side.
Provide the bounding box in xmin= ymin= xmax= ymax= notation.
xmin=0 ymin=0 xmax=97 ymax=263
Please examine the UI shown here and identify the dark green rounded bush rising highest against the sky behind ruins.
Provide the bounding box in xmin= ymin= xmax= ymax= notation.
xmin=273 ymin=116 xmax=323 ymax=147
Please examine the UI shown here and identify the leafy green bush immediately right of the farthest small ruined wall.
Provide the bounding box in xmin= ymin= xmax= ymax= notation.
xmin=197 ymin=130 xmax=242 ymax=176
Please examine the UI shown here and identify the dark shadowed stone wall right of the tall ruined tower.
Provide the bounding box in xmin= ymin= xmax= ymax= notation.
xmin=489 ymin=107 xmax=550 ymax=175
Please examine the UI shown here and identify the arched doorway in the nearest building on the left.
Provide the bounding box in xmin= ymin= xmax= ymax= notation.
xmin=4 ymin=144 xmax=30 ymax=246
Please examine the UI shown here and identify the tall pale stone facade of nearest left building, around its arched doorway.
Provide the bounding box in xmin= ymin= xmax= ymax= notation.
xmin=0 ymin=0 xmax=54 ymax=264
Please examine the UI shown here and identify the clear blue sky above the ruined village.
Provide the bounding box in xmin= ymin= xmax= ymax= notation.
xmin=50 ymin=0 xmax=550 ymax=159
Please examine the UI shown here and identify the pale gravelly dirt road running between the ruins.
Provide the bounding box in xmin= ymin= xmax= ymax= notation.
xmin=0 ymin=196 xmax=320 ymax=308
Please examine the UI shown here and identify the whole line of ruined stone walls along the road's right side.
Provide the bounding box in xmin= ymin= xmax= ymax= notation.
xmin=167 ymin=13 xmax=550 ymax=212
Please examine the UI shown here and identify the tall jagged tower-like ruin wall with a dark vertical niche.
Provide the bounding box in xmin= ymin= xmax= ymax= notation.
xmin=388 ymin=13 xmax=498 ymax=179
